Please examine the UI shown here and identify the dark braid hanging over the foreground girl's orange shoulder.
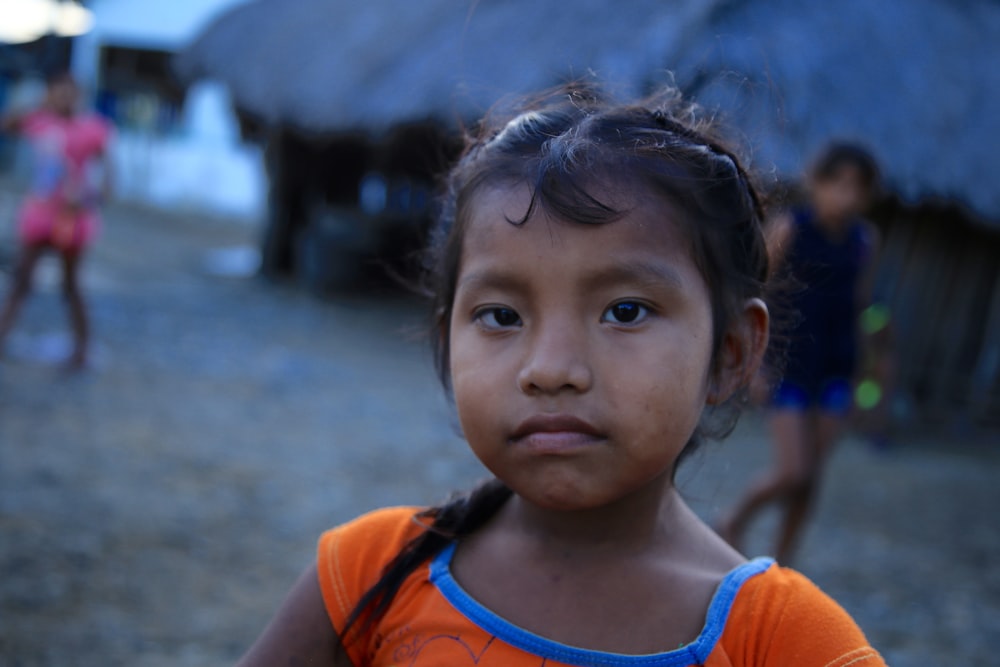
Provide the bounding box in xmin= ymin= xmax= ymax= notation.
xmin=341 ymin=478 xmax=511 ymax=645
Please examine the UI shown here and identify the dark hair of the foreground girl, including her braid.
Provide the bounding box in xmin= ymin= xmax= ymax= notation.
xmin=343 ymin=87 xmax=768 ymax=643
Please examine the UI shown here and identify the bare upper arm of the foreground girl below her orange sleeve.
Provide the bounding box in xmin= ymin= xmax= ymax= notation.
xmin=237 ymin=565 xmax=351 ymax=667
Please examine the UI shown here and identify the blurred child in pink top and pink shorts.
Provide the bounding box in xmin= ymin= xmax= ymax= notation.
xmin=0 ymin=73 xmax=110 ymax=369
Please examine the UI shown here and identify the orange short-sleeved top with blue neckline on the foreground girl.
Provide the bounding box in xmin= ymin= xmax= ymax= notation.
xmin=318 ymin=508 xmax=885 ymax=667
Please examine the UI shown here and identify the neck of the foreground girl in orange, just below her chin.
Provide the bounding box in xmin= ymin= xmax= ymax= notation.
xmin=504 ymin=477 xmax=687 ymax=553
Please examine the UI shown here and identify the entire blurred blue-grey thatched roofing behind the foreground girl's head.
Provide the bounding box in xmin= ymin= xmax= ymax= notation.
xmin=178 ymin=0 xmax=1000 ymax=222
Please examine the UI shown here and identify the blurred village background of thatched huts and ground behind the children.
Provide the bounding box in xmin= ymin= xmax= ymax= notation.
xmin=0 ymin=0 xmax=1000 ymax=665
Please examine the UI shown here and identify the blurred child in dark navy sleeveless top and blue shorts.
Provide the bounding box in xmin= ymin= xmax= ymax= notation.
xmin=721 ymin=143 xmax=878 ymax=563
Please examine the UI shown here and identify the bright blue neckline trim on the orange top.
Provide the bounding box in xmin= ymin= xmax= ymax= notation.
xmin=430 ymin=542 xmax=774 ymax=667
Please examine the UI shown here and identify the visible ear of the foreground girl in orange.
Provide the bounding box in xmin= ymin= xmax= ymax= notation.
xmin=705 ymin=299 xmax=770 ymax=405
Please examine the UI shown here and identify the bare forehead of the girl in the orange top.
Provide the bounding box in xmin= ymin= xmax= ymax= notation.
xmin=461 ymin=185 xmax=694 ymax=270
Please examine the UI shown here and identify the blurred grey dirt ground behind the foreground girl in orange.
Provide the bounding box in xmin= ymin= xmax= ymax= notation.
xmin=0 ymin=190 xmax=1000 ymax=667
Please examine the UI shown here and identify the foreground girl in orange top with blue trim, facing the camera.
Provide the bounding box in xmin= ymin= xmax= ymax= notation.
xmin=240 ymin=91 xmax=883 ymax=667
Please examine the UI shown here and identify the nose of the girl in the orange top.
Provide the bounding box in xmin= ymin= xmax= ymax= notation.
xmin=517 ymin=324 xmax=594 ymax=395
